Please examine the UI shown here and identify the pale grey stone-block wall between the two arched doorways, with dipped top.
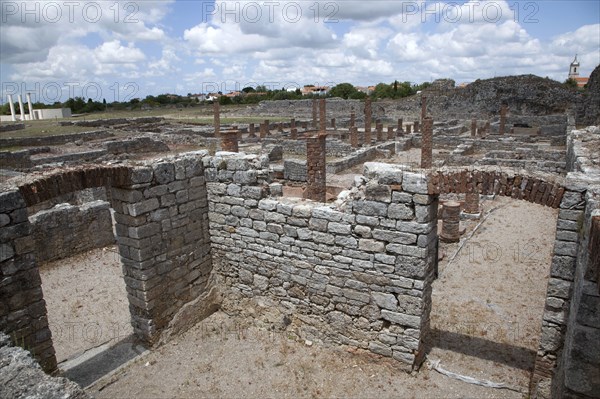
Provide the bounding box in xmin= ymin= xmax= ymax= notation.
xmin=205 ymin=156 xmax=437 ymax=368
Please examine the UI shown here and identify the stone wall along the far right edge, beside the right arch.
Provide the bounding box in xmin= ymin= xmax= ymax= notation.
xmin=549 ymin=127 xmax=600 ymax=398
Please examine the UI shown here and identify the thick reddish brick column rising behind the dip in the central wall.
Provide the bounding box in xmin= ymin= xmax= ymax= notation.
xmin=305 ymin=134 xmax=327 ymax=202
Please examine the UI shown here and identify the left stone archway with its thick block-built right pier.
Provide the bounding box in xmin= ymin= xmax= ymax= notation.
xmin=0 ymin=153 xmax=212 ymax=372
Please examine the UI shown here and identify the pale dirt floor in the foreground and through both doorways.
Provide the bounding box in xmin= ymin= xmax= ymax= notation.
xmin=42 ymin=198 xmax=556 ymax=398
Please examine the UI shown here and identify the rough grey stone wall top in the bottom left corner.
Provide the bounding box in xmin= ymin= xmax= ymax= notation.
xmin=0 ymin=332 xmax=89 ymax=399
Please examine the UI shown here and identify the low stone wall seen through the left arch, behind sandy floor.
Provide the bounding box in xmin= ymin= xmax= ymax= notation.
xmin=29 ymin=201 xmax=115 ymax=262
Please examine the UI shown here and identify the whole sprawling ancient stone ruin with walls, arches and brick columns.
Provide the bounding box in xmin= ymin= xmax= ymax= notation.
xmin=0 ymin=73 xmax=600 ymax=398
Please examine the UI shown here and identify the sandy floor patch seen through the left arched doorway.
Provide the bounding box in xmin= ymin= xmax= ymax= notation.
xmin=40 ymin=246 xmax=133 ymax=363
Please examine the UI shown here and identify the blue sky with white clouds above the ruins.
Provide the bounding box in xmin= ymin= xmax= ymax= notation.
xmin=0 ymin=0 xmax=600 ymax=103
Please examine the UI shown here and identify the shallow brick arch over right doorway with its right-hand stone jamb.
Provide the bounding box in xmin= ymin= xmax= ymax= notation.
xmin=423 ymin=167 xmax=586 ymax=394
